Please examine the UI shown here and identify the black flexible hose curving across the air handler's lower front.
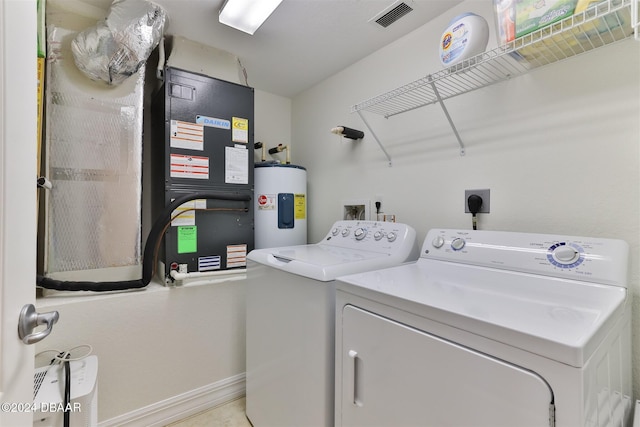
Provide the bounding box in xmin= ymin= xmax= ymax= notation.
xmin=36 ymin=191 xmax=251 ymax=292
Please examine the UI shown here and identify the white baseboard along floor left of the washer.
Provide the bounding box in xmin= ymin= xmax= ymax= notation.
xmin=98 ymin=373 xmax=246 ymax=427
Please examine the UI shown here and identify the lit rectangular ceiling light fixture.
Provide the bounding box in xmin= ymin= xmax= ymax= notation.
xmin=218 ymin=0 xmax=282 ymax=35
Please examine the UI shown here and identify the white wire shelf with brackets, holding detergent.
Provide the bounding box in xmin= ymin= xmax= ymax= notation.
xmin=351 ymin=0 xmax=640 ymax=163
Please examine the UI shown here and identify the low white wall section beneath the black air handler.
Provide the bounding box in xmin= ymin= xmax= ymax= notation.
xmin=37 ymin=281 xmax=245 ymax=425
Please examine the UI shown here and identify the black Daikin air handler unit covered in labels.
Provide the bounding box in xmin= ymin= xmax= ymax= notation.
xmin=151 ymin=67 xmax=254 ymax=277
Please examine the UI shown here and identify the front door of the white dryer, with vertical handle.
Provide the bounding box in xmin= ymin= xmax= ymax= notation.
xmin=336 ymin=306 xmax=553 ymax=427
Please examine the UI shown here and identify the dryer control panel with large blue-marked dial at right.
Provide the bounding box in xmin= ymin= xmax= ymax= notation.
xmin=420 ymin=229 xmax=629 ymax=287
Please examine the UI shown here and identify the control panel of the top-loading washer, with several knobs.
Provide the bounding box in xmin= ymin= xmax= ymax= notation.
xmin=319 ymin=220 xmax=416 ymax=252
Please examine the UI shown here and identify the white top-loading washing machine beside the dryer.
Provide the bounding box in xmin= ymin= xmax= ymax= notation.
xmin=246 ymin=221 xmax=419 ymax=427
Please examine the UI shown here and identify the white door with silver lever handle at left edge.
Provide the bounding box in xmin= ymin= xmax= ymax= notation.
xmin=0 ymin=0 xmax=37 ymax=426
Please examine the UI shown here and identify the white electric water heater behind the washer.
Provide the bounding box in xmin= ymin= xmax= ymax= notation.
xmin=254 ymin=162 xmax=307 ymax=249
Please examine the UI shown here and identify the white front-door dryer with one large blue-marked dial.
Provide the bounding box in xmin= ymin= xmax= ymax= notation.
xmin=335 ymin=230 xmax=633 ymax=427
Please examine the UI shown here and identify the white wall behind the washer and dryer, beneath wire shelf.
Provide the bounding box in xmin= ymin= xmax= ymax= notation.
xmin=292 ymin=1 xmax=640 ymax=402
